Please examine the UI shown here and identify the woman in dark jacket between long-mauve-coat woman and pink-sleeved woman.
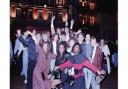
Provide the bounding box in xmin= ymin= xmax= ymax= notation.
xmin=53 ymin=42 xmax=71 ymax=89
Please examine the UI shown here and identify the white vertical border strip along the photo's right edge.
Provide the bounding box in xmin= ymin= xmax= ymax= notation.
xmin=118 ymin=0 xmax=128 ymax=89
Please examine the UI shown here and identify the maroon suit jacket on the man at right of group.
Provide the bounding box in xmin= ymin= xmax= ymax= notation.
xmin=92 ymin=46 xmax=103 ymax=70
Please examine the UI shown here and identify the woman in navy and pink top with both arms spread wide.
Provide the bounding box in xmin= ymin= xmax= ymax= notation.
xmin=53 ymin=43 xmax=103 ymax=89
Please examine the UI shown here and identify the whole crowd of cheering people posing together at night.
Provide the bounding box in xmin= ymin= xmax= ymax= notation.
xmin=10 ymin=16 xmax=117 ymax=89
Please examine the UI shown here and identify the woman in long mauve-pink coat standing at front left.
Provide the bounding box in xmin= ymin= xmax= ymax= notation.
xmin=33 ymin=42 xmax=55 ymax=89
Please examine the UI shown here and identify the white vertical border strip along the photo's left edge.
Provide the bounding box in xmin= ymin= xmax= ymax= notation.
xmin=0 ymin=0 xmax=10 ymax=89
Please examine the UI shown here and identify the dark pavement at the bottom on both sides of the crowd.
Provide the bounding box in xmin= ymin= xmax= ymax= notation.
xmin=10 ymin=64 xmax=118 ymax=89
